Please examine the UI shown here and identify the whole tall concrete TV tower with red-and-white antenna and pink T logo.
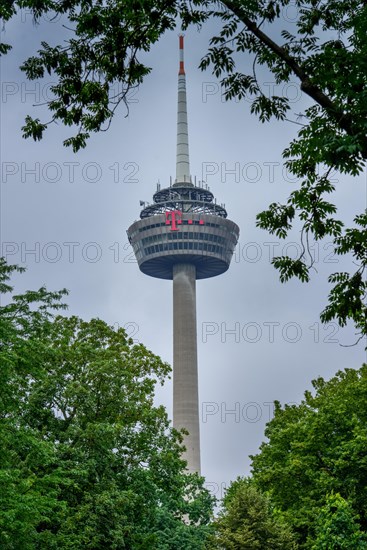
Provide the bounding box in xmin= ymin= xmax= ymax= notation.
xmin=127 ymin=35 xmax=239 ymax=474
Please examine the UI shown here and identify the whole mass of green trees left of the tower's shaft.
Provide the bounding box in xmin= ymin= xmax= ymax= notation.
xmin=0 ymin=261 xmax=212 ymax=550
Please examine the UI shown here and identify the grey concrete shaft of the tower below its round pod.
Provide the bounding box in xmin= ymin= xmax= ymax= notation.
xmin=173 ymin=263 xmax=200 ymax=474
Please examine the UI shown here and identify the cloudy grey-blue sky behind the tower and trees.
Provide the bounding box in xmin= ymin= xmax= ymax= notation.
xmin=1 ymin=9 xmax=366 ymax=497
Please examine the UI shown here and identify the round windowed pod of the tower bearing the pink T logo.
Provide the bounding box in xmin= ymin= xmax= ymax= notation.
xmin=127 ymin=181 xmax=239 ymax=279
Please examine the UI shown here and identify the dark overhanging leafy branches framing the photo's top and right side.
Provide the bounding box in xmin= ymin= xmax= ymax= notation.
xmin=0 ymin=0 xmax=367 ymax=341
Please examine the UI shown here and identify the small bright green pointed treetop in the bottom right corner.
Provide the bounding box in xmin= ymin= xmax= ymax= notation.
xmin=312 ymin=494 xmax=367 ymax=550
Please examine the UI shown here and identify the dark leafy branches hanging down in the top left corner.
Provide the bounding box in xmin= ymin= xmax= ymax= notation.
xmin=3 ymin=0 xmax=176 ymax=152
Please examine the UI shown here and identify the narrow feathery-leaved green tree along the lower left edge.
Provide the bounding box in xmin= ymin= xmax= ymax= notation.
xmin=0 ymin=258 xmax=66 ymax=550
